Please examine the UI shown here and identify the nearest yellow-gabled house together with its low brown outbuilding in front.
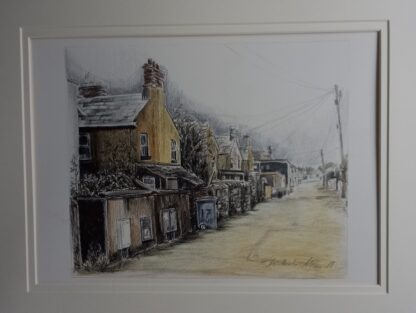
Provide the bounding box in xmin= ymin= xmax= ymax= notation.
xmin=74 ymin=59 xmax=203 ymax=264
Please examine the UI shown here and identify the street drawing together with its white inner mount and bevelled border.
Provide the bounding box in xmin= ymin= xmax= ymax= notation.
xmin=1 ymin=11 xmax=398 ymax=312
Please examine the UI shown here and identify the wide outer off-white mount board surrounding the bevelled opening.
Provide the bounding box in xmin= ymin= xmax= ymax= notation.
xmin=0 ymin=1 xmax=416 ymax=312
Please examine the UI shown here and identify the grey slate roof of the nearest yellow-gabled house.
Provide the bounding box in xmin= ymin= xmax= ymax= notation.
xmin=78 ymin=93 xmax=148 ymax=127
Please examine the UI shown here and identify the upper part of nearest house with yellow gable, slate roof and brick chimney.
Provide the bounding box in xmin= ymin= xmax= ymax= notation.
xmin=78 ymin=60 xmax=181 ymax=171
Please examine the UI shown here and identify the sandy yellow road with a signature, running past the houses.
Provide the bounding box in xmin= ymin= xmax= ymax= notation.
xmin=119 ymin=181 xmax=347 ymax=278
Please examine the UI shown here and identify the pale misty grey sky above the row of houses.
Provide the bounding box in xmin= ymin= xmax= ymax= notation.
xmin=67 ymin=33 xmax=376 ymax=165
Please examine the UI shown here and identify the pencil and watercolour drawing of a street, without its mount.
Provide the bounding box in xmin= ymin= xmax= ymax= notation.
xmin=65 ymin=35 xmax=364 ymax=278
